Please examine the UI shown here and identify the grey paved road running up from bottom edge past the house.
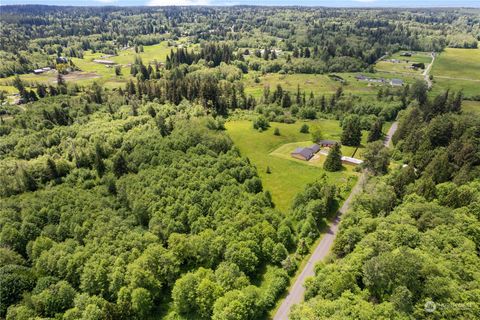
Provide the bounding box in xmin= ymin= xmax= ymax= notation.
xmin=273 ymin=122 xmax=398 ymax=320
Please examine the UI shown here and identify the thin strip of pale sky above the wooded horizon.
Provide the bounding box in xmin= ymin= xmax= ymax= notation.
xmin=0 ymin=0 xmax=480 ymax=10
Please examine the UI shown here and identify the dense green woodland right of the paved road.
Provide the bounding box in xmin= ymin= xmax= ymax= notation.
xmin=291 ymin=92 xmax=480 ymax=319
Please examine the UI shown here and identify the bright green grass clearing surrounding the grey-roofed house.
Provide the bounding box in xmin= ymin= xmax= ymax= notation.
xmin=225 ymin=120 xmax=358 ymax=212
